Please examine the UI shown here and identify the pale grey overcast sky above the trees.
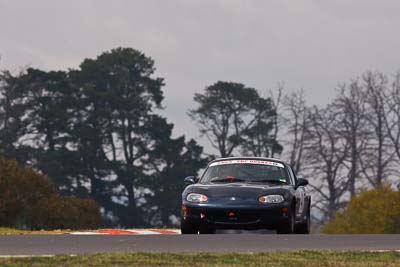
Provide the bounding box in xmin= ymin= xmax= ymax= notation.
xmin=0 ymin=0 xmax=400 ymax=151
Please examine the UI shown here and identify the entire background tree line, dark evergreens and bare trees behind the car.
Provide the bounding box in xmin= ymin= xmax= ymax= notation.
xmin=0 ymin=48 xmax=400 ymax=227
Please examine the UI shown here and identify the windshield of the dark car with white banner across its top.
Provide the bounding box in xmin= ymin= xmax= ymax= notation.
xmin=199 ymin=160 xmax=289 ymax=184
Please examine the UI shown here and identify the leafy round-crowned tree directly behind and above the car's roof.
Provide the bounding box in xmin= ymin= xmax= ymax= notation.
xmin=189 ymin=81 xmax=280 ymax=157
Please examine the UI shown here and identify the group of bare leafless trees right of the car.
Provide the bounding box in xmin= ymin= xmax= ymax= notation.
xmin=281 ymin=72 xmax=400 ymax=223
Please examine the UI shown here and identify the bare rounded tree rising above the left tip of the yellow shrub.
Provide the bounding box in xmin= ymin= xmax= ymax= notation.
xmin=305 ymin=106 xmax=349 ymax=221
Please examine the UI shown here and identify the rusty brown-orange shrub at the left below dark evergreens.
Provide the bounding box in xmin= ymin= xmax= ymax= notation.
xmin=0 ymin=157 xmax=100 ymax=229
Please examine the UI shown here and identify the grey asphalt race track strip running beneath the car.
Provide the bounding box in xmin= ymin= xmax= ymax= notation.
xmin=0 ymin=234 xmax=400 ymax=256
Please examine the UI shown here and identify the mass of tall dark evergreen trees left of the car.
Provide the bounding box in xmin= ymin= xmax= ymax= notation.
xmin=0 ymin=48 xmax=208 ymax=227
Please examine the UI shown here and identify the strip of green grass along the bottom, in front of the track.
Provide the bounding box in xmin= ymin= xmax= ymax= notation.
xmin=0 ymin=251 xmax=400 ymax=267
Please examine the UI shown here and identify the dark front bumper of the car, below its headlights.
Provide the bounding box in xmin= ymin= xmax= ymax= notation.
xmin=182 ymin=202 xmax=290 ymax=230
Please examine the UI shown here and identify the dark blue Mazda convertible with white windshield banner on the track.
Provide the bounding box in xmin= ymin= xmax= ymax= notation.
xmin=181 ymin=157 xmax=311 ymax=234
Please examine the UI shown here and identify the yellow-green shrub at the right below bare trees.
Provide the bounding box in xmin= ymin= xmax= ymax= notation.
xmin=322 ymin=185 xmax=400 ymax=234
